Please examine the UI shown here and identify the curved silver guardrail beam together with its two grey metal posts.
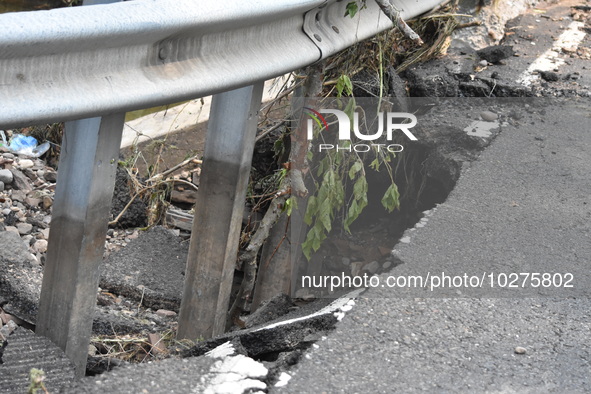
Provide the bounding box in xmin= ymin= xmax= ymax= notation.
xmin=0 ymin=0 xmax=441 ymax=376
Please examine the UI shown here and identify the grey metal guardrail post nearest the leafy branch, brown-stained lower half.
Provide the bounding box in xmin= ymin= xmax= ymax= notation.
xmin=177 ymin=82 xmax=263 ymax=340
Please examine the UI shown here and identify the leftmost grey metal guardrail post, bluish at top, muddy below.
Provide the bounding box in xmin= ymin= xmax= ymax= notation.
xmin=36 ymin=113 xmax=125 ymax=377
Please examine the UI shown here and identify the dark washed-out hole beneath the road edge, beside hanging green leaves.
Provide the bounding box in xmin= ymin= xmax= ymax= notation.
xmin=296 ymin=114 xmax=470 ymax=297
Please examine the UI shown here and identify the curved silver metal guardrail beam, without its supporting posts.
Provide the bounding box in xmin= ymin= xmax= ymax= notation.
xmin=0 ymin=0 xmax=441 ymax=128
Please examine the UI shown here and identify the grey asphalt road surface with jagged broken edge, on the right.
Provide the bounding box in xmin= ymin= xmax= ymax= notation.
xmin=273 ymin=1 xmax=591 ymax=393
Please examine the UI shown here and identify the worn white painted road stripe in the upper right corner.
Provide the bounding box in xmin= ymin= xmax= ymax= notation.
xmin=517 ymin=22 xmax=585 ymax=86
